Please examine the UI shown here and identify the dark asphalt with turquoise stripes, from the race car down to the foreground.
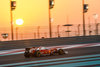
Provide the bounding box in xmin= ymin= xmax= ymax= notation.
xmin=0 ymin=46 xmax=100 ymax=67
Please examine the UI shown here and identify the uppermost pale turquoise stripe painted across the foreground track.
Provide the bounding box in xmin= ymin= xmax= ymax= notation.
xmin=0 ymin=54 xmax=100 ymax=67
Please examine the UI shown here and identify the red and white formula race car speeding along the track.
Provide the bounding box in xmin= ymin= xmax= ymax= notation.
xmin=24 ymin=47 xmax=65 ymax=58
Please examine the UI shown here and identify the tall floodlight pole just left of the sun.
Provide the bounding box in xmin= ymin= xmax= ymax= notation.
xmin=10 ymin=0 xmax=16 ymax=40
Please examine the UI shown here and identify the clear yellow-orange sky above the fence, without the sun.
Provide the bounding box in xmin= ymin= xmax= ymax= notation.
xmin=0 ymin=0 xmax=100 ymax=27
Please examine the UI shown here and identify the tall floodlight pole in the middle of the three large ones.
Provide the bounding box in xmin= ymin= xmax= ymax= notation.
xmin=48 ymin=0 xmax=54 ymax=38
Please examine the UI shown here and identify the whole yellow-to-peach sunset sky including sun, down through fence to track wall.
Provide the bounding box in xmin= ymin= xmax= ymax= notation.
xmin=0 ymin=0 xmax=100 ymax=39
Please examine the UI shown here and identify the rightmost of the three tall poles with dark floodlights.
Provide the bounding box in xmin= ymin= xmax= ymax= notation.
xmin=82 ymin=0 xmax=88 ymax=36
